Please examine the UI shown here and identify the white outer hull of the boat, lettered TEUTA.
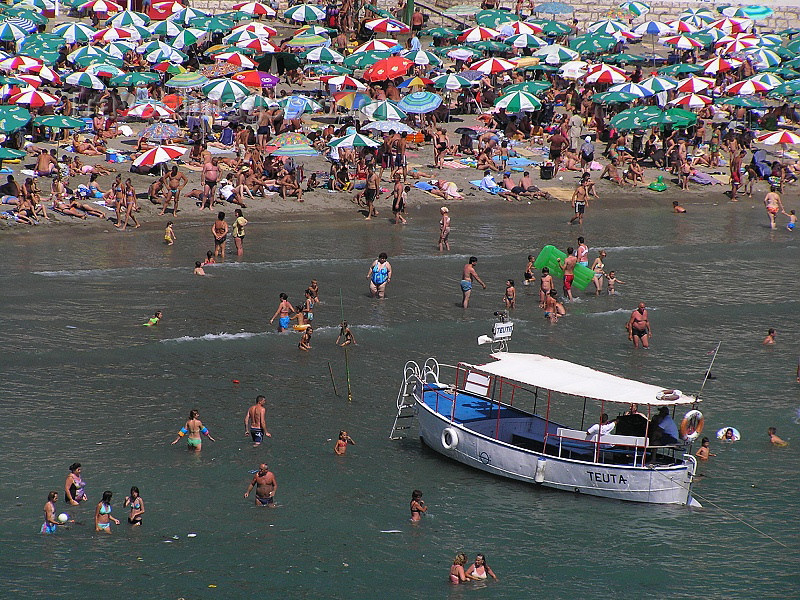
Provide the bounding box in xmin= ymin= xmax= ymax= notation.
xmin=417 ymin=402 xmax=698 ymax=506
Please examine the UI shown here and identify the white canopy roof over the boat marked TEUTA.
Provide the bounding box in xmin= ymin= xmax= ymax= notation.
xmin=475 ymin=352 xmax=698 ymax=406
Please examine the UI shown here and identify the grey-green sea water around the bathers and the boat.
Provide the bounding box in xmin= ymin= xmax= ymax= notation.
xmin=0 ymin=200 xmax=800 ymax=598
